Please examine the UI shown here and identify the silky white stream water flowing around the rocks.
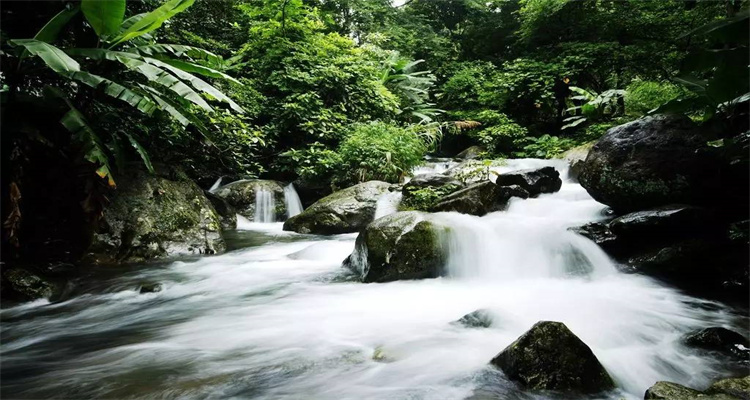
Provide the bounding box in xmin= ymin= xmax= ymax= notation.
xmin=0 ymin=160 xmax=747 ymax=399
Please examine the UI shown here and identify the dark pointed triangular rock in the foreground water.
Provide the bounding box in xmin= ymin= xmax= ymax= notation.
xmin=490 ymin=321 xmax=615 ymax=393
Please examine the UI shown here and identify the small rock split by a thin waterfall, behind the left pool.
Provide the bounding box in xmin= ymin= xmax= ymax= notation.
xmin=214 ymin=179 xmax=286 ymax=221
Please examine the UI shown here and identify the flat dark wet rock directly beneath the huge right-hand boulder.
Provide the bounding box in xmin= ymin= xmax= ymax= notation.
xmin=609 ymin=204 xmax=716 ymax=240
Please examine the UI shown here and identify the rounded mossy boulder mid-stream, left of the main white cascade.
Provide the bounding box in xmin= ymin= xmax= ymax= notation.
xmin=345 ymin=211 xmax=446 ymax=282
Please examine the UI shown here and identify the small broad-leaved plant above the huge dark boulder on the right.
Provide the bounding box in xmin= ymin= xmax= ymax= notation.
xmin=562 ymin=86 xmax=625 ymax=129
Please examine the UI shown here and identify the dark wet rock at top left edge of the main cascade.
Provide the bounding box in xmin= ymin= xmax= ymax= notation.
xmin=430 ymin=181 xmax=507 ymax=216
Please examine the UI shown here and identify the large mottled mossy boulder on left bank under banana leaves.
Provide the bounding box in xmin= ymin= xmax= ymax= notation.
xmin=85 ymin=167 xmax=225 ymax=264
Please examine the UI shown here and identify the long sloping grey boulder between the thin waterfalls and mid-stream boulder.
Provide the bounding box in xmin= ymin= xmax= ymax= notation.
xmin=284 ymin=181 xmax=392 ymax=234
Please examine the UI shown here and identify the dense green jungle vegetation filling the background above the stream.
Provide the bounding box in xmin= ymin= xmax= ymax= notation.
xmin=0 ymin=0 xmax=750 ymax=260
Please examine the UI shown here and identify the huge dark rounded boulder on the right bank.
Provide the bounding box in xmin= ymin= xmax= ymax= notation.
xmin=579 ymin=115 xmax=719 ymax=213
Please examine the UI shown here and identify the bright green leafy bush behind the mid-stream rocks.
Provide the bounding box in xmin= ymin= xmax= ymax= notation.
xmin=338 ymin=122 xmax=427 ymax=184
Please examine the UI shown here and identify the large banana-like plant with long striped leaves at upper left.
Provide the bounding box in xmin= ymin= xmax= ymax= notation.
xmin=8 ymin=0 xmax=243 ymax=186
